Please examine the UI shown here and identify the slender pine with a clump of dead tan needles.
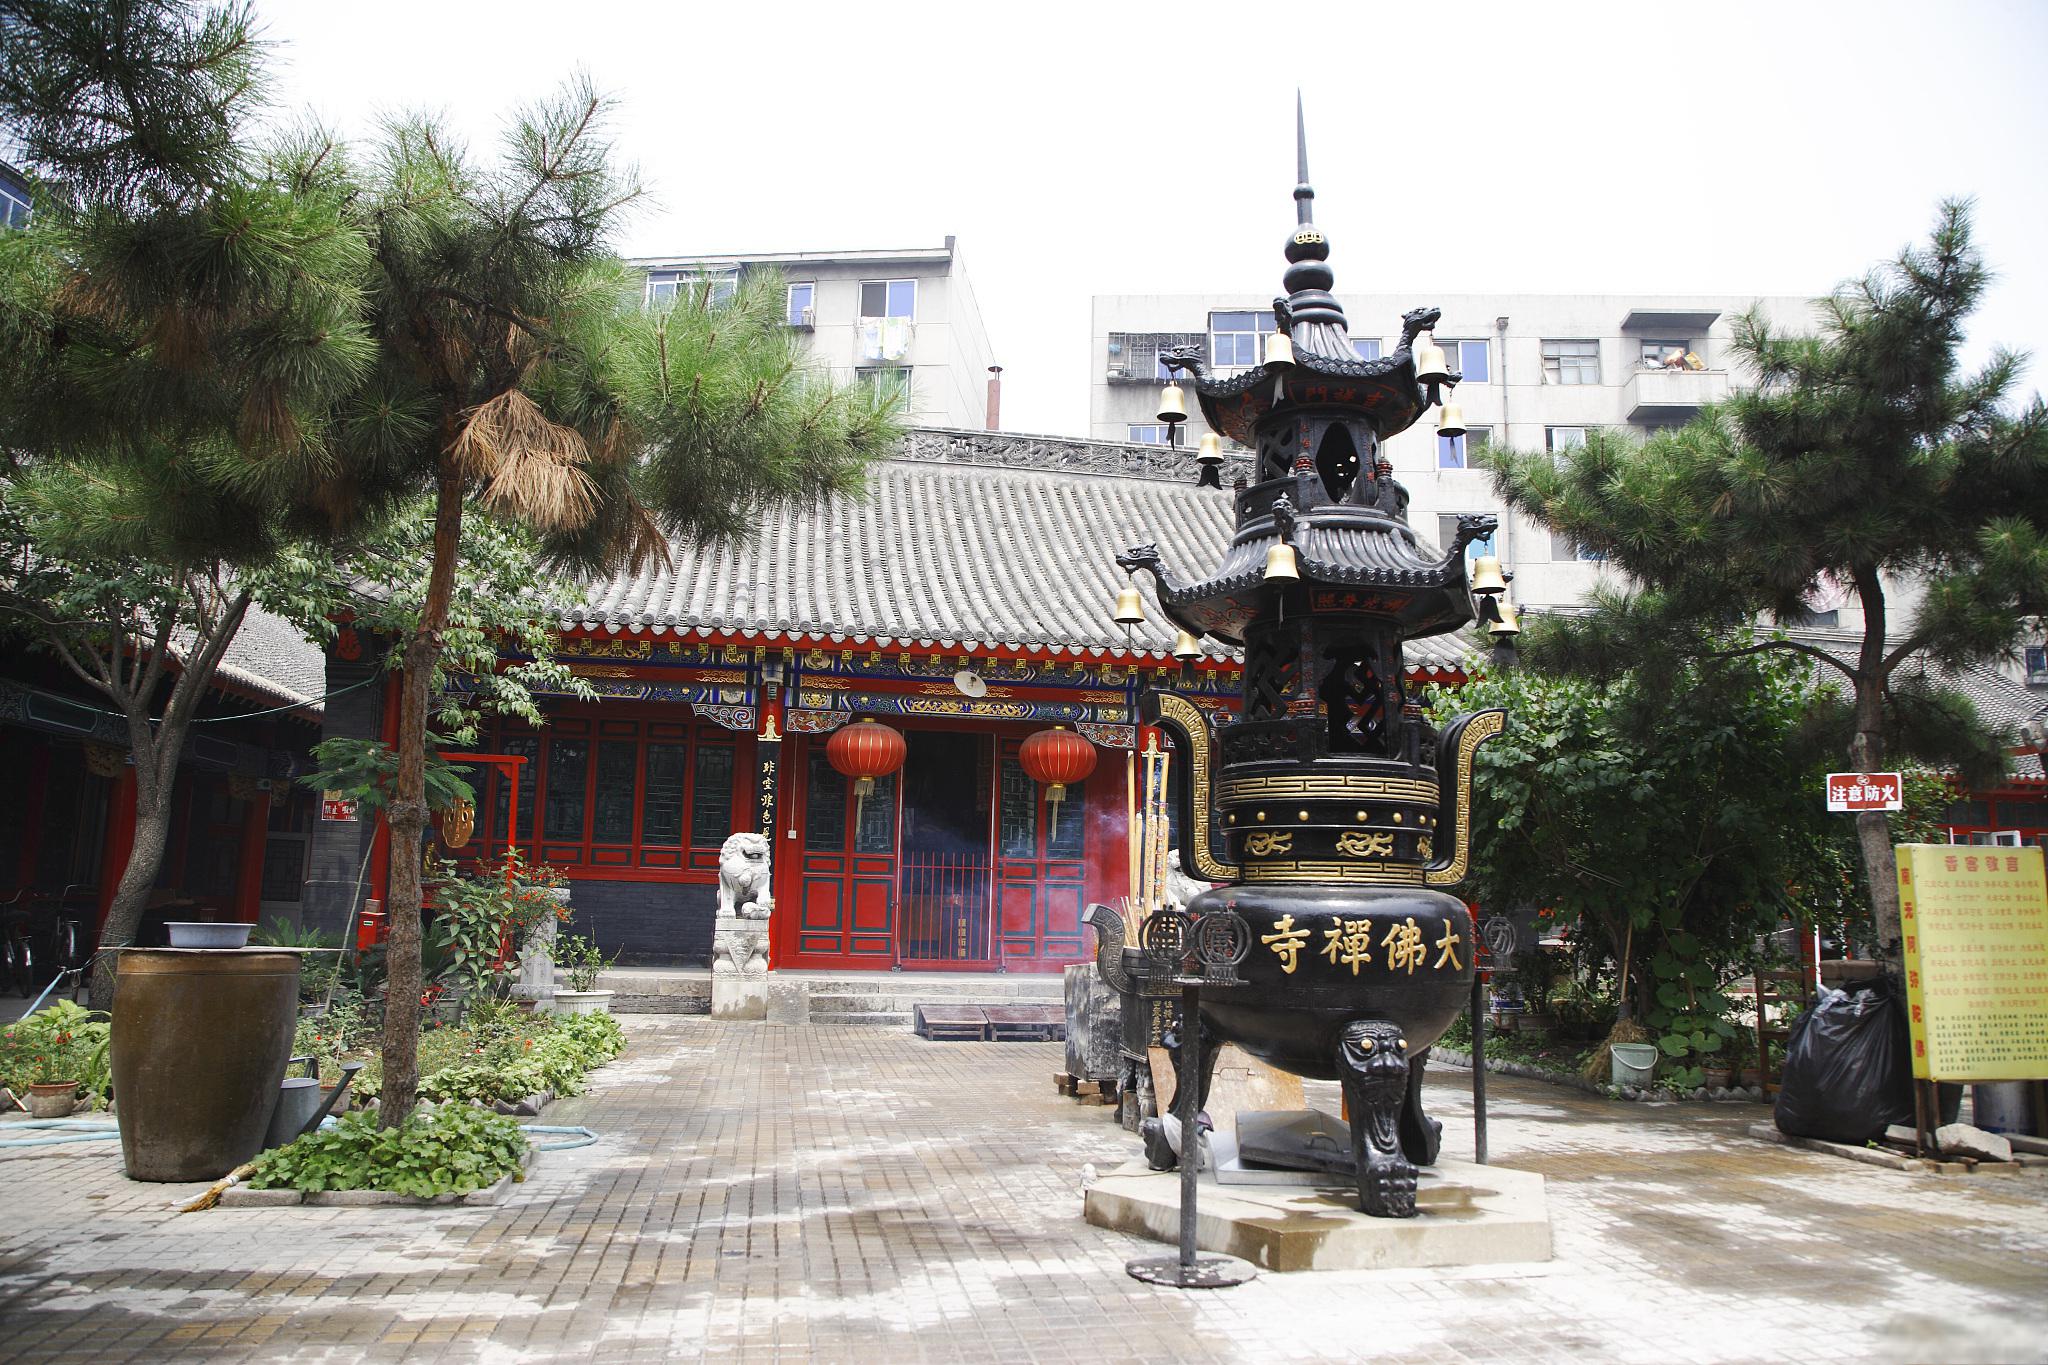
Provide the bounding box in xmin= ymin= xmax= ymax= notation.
xmin=319 ymin=82 xmax=897 ymax=1124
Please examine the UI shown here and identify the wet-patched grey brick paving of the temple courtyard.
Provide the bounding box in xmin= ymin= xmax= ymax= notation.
xmin=0 ymin=1017 xmax=2048 ymax=1365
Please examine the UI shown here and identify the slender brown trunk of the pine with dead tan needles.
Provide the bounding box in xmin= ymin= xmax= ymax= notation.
xmin=377 ymin=464 xmax=463 ymax=1128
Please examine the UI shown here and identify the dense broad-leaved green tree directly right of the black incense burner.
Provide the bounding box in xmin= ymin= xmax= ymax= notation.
xmin=1436 ymin=646 xmax=1847 ymax=1062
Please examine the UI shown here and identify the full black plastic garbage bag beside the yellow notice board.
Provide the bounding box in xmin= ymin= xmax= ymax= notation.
xmin=1776 ymin=976 xmax=1913 ymax=1144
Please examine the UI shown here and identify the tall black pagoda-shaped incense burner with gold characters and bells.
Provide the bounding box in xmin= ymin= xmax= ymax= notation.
xmin=1092 ymin=112 xmax=1503 ymax=1218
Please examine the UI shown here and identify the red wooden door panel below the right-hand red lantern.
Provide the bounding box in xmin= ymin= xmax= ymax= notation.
xmin=995 ymin=739 xmax=1090 ymax=972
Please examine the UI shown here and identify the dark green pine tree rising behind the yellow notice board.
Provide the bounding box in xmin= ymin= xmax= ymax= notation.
xmin=1491 ymin=203 xmax=2048 ymax=960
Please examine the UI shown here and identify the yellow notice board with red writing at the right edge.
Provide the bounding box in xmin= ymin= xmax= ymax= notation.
xmin=1898 ymin=843 xmax=2048 ymax=1081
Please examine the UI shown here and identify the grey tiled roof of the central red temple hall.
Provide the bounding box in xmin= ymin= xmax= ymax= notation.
xmin=563 ymin=430 xmax=1470 ymax=667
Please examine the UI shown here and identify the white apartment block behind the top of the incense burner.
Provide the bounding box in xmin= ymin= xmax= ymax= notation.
xmin=1090 ymin=293 xmax=1826 ymax=628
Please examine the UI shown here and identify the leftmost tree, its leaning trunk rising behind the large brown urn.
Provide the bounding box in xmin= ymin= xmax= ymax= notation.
xmin=0 ymin=0 xmax=375 ymax=1005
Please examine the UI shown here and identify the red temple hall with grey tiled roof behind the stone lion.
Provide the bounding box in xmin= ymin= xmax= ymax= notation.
xmin=307 ymin=428 xmax=1470 ymax=972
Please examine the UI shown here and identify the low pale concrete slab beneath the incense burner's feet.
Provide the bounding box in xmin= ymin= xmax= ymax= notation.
xmin=1083 ymin=1160 xmax=1550 ymax=1271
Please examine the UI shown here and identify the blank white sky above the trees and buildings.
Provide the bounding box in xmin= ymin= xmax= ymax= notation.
xmin=260 ymin=0 xmax=2048 ymax=434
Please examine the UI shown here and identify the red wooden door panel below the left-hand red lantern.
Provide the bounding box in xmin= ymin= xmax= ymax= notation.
xmin=788 ymin=743 xmax=901 ymax=970
